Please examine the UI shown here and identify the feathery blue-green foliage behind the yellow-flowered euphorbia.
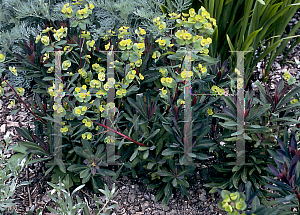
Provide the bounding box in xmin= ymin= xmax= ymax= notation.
xmin=0 ymin=0 xmax=191 ymax=88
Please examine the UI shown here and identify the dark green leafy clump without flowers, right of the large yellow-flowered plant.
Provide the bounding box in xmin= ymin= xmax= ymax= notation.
xmin=208 ymin=80 xmax=300 ymax=204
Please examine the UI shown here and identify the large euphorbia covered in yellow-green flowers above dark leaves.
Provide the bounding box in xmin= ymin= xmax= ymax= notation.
xmin=0 ymin=1 xmax=224 ymax=204
